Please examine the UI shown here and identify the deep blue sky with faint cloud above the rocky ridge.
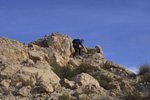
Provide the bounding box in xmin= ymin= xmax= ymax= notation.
xmin=0 ymin=0 xmax=150 ymax=71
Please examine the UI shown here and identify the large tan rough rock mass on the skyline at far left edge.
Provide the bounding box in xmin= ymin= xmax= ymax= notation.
xmin=0 ymin=37 xmax=28 ymax=63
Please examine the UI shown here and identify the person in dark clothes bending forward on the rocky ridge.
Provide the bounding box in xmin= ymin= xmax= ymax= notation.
xmin=72 ymin=39 xmax=84 ymax=57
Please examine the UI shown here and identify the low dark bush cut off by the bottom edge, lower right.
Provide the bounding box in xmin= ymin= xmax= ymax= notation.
xmin=123 ymin=92 xmax=144 ymax=100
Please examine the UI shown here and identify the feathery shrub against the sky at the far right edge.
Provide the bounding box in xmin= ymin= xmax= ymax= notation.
xmin=138 ymin=64 xmax=150 ymax=75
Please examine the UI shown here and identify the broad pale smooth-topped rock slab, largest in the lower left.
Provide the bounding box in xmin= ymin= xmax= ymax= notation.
xmin=12 ymin=67 xmax=60 ymax=84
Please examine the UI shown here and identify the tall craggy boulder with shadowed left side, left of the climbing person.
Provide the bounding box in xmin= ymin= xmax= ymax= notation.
xmin=31 ymin=33 xmax=73 ymax=66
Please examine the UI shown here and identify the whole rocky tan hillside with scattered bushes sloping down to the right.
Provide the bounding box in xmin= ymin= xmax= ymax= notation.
xmin=0 ymin=33 xmax=150 ymax=100
